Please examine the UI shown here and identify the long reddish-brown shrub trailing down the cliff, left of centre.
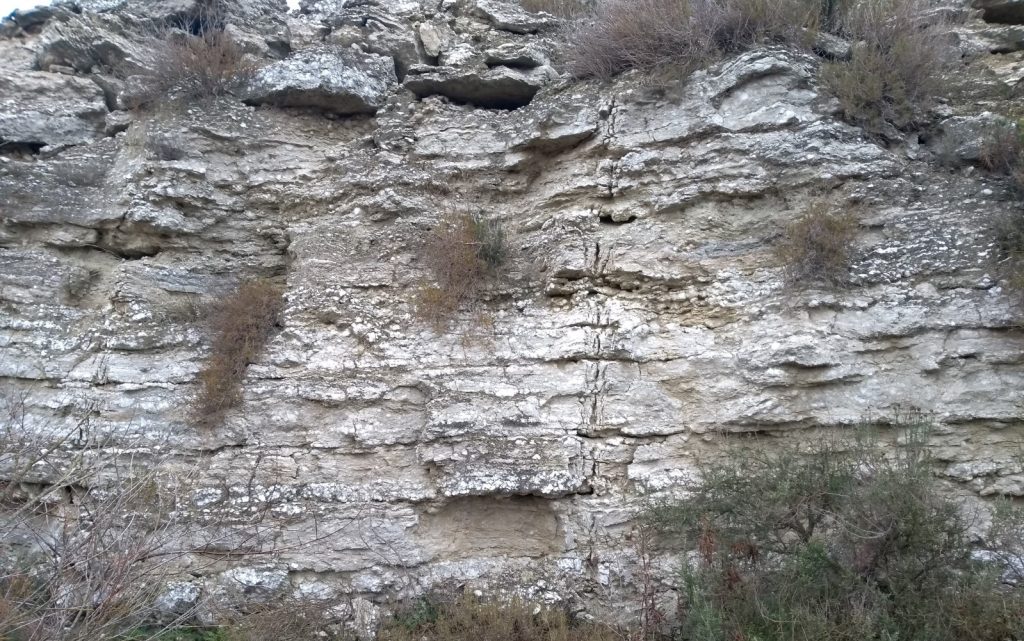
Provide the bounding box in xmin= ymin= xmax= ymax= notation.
xmin=195 ymin=280 xmax=283 ymax=426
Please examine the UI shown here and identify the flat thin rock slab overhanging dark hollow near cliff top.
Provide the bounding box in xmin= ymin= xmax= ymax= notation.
xmin=404 ymin=67 xmax=554 ymax=109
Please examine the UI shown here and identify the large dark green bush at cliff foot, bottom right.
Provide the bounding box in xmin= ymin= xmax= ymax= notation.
xmin=652 ymin=425 xmax=1024 ymax=641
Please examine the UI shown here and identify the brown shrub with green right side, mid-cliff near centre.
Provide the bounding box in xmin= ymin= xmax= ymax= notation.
xmin=417 ymin=212 xmax=507 ymax=326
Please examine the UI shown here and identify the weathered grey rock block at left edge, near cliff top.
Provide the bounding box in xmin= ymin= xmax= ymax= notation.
xmin=0 ymin=72 xmax=106 ymax=145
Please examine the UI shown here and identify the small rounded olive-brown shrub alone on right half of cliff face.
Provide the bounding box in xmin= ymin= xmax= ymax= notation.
xmin=775 ymin=202 xmax=857 ymax=285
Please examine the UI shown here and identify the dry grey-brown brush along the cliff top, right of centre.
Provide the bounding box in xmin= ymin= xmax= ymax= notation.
xmin=568 ymin=0 xmax=949 ymax=132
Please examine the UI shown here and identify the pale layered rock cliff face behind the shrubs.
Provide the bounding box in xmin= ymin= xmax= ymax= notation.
xmin=0 ymin=0 xmax=1024 ymax=621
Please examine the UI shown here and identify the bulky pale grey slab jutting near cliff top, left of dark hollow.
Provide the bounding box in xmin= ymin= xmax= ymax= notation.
xmin=245 ymin=47 xmax=398 ymax=115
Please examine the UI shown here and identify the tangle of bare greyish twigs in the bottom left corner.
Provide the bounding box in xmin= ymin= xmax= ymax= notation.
xmin=0 ymin=389 xmax=202 ymax=641
